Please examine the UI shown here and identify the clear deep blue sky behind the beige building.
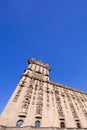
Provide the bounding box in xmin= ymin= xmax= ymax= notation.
xmin=0 ymin=0 xmax=87 ymax=113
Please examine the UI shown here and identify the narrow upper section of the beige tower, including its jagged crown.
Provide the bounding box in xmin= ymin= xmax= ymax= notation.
xmin=25 ymin=58 xmax=51 ymax=81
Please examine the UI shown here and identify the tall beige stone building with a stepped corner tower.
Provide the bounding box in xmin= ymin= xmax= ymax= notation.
xmin=0 ymin=58 xmax=87 ymax=130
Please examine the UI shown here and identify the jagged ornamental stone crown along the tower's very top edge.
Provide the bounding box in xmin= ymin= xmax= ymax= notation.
xmin=28 ymin=58 xmax=51 ymax=71
